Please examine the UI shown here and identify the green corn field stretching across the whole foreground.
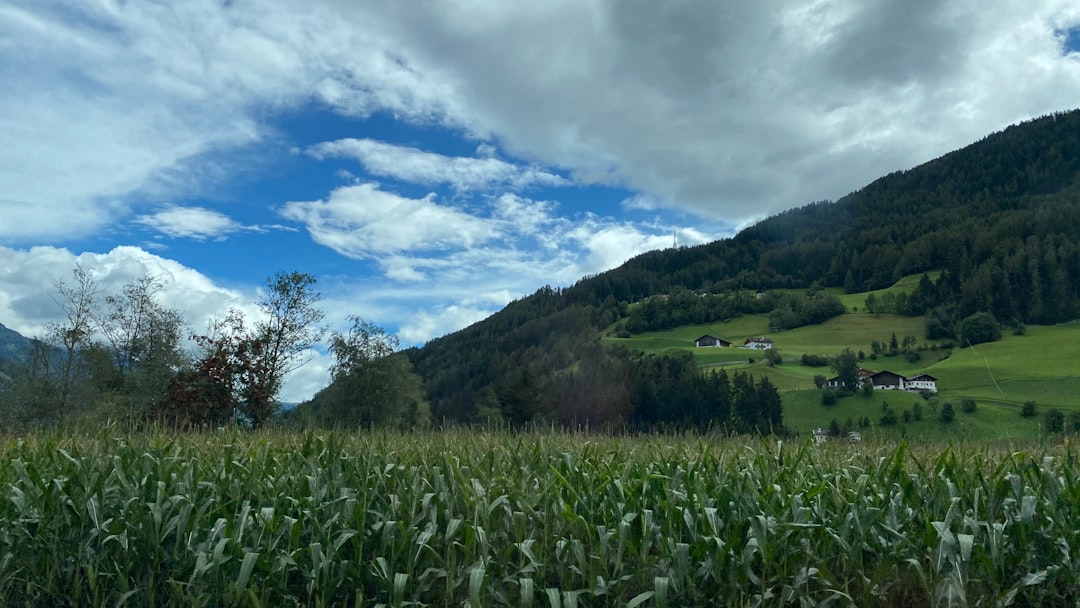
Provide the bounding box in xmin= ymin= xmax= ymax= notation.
xmin=0 ymin=431 xmax=1080 ymax=608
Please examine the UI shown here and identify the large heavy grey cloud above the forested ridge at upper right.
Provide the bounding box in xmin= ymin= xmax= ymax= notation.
xmin=358 ymin=0 xmax=1080 ymax=221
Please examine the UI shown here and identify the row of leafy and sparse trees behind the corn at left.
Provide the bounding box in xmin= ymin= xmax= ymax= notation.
xmin=0 ymin=266 xmax=429 ymax=429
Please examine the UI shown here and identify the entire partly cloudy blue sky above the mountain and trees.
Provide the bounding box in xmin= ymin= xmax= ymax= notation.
xmin=0 ymin=0 xmax=1080 ymax=401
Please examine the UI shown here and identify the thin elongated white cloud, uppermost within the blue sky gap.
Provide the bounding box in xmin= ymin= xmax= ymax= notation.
xmin=308 ymin=139 xmax=568 ymax=191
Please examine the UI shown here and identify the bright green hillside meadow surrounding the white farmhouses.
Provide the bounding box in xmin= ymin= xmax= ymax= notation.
xmin=607 ymin=306 xmax=1080 ymax=440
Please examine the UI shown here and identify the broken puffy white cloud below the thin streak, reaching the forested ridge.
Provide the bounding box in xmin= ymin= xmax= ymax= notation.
xmin=286 ymin=191 xmax=728 ymax=344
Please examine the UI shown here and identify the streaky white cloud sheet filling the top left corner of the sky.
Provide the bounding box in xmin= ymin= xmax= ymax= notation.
xmin=0 ymin=0 xmax=473 ymax=241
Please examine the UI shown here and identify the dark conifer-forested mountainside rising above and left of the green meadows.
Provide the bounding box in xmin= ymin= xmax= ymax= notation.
xmin=408 ymin=111 xmax=1080 ymax=422
